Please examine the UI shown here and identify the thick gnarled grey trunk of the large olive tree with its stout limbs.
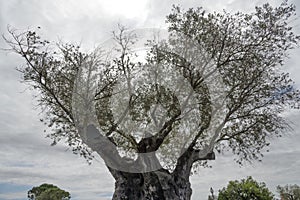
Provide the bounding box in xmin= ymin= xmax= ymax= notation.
xmin=86 ymin=126 xmax=215 ymax=200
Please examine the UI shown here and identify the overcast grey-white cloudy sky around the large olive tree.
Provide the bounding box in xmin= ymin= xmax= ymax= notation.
xmin=0 ymin=0 xmax=300 ymax=200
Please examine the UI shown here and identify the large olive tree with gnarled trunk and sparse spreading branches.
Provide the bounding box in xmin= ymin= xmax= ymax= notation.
xmin=5 ymin=2 xmax=300 ymax=200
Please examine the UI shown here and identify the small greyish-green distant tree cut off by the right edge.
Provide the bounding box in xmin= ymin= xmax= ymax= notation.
xmin=277 ymin=184 xmax=300 ymax=200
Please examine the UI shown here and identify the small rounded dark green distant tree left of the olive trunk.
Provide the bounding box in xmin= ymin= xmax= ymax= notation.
xmin=28 ymin=183 xmax=71 ymax=200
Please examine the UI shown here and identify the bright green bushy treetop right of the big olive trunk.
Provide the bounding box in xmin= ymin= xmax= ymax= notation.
xmin=218 ymin=176 xmax=274 ymax=200
